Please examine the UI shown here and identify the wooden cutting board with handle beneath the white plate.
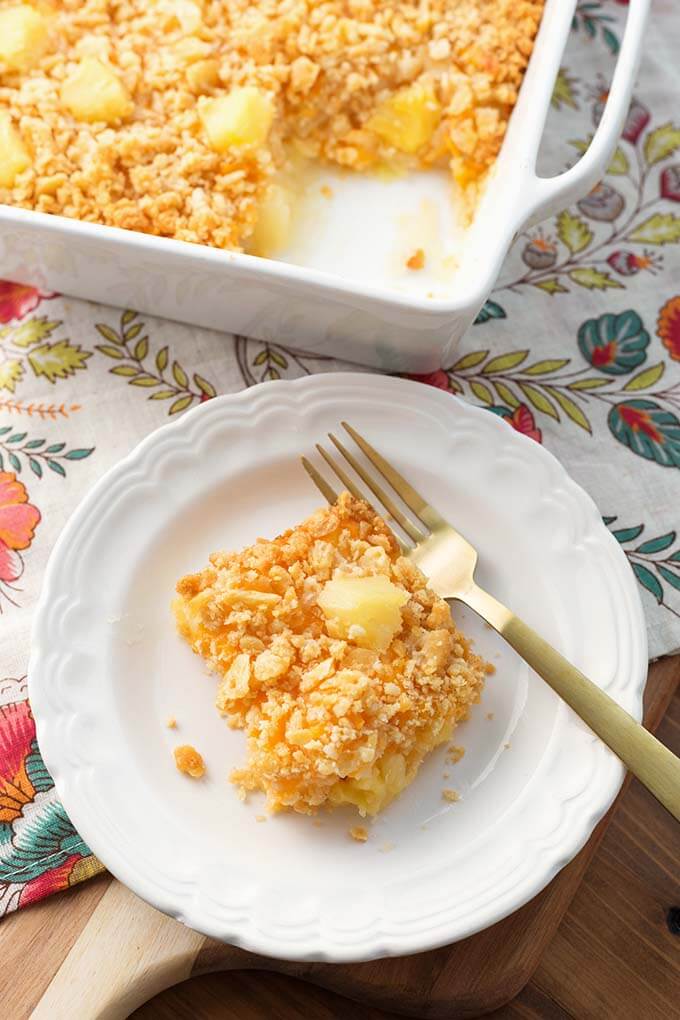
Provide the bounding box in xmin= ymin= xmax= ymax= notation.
xmin=13 ymin=658 xmax=680 ymax=1020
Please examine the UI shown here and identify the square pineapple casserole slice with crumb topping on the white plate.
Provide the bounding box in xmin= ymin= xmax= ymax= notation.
xmin=173 ymin=493 xmax=489 ymax=815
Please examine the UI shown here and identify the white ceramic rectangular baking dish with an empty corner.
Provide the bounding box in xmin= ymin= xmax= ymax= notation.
xmin=0 ymin=0 xmax=649 ymax=372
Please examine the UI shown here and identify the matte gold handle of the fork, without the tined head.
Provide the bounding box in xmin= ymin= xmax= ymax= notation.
xmin=458 ymin=584 xmax=680 ymax=821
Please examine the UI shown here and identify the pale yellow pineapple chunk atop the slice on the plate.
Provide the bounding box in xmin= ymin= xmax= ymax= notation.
xmin=317 ymin=574 xmax=409 ymax=652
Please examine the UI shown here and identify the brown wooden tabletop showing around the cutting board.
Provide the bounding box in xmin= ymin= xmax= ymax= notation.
xmin=0 ymin=673 xmax=680 ymax=1020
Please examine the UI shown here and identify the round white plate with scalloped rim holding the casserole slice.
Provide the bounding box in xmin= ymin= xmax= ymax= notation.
xmin=30 ymin=374 xmax=646 ymax=961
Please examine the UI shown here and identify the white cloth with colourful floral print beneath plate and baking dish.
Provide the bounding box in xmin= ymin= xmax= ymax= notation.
xmin=0 ymin=0 xmax=680 ymax=915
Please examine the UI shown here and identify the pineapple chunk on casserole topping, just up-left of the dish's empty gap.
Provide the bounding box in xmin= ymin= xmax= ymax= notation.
xmin=199 ymin=85 xmax=274 ymax=152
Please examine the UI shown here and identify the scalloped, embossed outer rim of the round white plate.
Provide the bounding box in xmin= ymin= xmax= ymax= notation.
xmin=29 ymin=374 xmax=646 ymax=962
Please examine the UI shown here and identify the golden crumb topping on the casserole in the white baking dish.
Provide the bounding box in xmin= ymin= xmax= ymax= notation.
xmin=0 ymin=0 xmax=543 ymax=249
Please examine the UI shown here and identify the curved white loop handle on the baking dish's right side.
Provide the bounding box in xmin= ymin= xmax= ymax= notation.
xmin=522 ymin=0 xmax=650 ymax=226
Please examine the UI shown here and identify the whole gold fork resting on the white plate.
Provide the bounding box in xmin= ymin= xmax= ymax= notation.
xmin=302 ymin=421 xmax=680 ymax=821
